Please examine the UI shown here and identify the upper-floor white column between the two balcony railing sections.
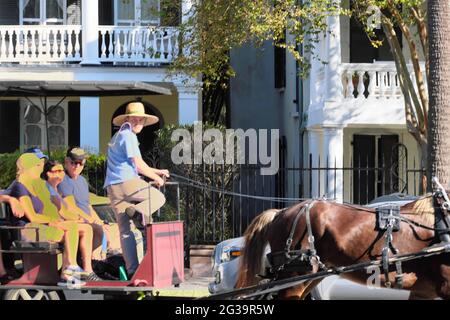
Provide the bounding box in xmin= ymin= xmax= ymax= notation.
xmin=81 ymin=0 xmax=100 ymax=65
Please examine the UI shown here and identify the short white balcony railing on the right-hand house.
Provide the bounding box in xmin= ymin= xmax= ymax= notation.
xmin=340 ymin=62 xmax=402 ymax=99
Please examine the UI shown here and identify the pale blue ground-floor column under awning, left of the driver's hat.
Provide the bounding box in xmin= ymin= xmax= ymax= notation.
xmin=80 ymin=97 xmax=100 ymax=153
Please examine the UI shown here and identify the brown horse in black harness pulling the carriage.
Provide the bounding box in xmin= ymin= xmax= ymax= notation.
xmin=210 ymin=181 xmax=450 ymax=299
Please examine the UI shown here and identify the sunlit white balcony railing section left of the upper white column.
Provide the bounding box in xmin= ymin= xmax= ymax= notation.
xmin=0 ymin=25 xmax=81 ymax=63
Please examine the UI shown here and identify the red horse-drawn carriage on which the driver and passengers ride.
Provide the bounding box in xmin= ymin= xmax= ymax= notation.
xmin=0 ymin=182 xmax=184 ymax=300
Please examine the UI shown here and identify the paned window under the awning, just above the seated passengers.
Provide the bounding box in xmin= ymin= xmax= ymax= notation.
xmin=20 ymin=99 xmax=68 ymax=149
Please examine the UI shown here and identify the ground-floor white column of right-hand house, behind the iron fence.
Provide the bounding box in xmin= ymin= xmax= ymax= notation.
xmin=323 ymin=128 xmax=344 ymax=203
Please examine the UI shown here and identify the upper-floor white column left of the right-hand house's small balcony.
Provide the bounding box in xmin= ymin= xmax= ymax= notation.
xmin=325 ymin=0 xmax=342 ymax=101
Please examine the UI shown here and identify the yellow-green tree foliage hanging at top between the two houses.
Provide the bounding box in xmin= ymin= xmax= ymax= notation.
xmin=167 ymin=0 xmax=346 ymax=86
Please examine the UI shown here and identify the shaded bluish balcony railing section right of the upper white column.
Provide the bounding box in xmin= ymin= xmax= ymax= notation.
xmin=99 ymin=26 xmax=178 ymax=63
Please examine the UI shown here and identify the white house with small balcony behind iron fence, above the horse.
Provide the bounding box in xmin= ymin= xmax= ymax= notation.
xmin=231 ymin=2 xmax=420 ymax=203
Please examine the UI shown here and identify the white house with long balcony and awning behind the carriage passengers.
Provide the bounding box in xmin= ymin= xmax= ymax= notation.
xmin=0 ymin=0 xmax=201 ymax=152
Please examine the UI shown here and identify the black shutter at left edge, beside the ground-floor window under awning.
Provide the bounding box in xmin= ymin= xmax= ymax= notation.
xmin=0 ymin=100 xmax=20 ymax=153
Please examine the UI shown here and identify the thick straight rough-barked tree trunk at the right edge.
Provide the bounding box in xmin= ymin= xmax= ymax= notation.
xmin=427 ymin=0 xmax=450 ymax=190
